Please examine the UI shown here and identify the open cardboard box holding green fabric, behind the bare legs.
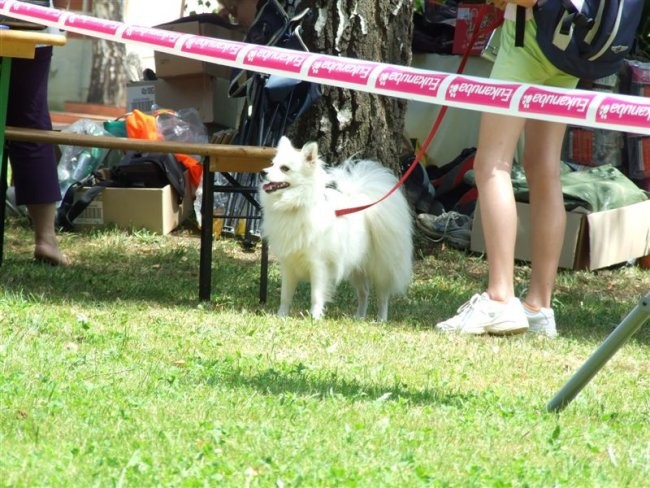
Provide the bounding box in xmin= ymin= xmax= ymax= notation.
xmin=470 ymin=200 xmax=650 ymax=270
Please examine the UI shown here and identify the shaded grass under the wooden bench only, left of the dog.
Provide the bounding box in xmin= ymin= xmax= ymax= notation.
xmin=0 ymin=222 xmax=268 ymax=307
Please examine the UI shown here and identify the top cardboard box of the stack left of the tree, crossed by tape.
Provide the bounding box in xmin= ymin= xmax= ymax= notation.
xmin=154 ymin=19 xmax=244 ymax=79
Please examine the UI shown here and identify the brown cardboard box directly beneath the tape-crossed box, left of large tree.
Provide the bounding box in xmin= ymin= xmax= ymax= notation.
xmin=156 ymin=75 xmax=244 ymax=128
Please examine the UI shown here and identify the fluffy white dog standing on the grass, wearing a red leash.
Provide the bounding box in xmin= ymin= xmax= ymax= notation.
xmin=260 ymin=137 xmax=413 ymax=321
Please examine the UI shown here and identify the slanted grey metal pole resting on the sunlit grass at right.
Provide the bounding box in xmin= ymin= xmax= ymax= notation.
xmin=546 ymin=293 xmax=650 ymax=412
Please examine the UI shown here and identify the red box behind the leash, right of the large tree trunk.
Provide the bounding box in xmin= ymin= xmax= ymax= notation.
xmin=451 ymin=3 xmax=503 ymax=56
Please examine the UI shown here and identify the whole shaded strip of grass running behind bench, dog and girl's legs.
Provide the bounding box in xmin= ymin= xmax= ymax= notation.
xmin=0 ymin=224 xmax=650 ymax=344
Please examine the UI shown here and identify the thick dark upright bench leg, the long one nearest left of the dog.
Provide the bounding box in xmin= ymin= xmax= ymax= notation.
xmin=199 ymin=164 xmax=214 ymax=301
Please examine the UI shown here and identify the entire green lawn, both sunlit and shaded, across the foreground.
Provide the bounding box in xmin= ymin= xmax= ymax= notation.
xmin=0 ymin=221 xmax=650 ymax=487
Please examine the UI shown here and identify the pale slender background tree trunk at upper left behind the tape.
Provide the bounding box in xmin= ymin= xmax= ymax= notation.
xmin=86 ymin=0 xmax=127 ymax=107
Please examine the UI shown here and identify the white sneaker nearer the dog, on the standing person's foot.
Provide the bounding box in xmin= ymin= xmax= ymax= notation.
xmin=436 ymin=293 xmax=528 ymax=335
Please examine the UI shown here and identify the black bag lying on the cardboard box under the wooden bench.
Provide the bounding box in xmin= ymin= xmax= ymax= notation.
xmin=56 ymin=151 xmax=185 ymax=230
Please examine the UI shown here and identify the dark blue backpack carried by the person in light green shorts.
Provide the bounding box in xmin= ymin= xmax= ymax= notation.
xmin=517 ymin=0 xmax=644 ymax=80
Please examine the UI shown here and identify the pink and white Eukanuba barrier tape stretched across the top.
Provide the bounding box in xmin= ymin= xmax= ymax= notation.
xmin=0 ymin=0 xmax=650 ymax=135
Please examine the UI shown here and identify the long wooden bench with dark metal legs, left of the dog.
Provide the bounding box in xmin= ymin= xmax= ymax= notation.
xmin=0 ymin=127 xmax=275 ymax=301
